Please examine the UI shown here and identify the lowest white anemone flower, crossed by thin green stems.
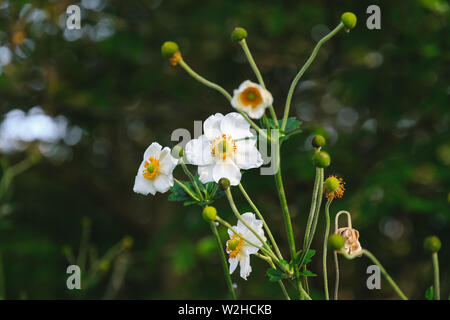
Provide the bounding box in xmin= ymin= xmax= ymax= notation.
xmin=226 ymin=212 xmax=266 ymax=280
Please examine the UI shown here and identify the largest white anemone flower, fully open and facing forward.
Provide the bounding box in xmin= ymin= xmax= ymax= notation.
xmin=185 ymin=112 xmax=263 ymax=186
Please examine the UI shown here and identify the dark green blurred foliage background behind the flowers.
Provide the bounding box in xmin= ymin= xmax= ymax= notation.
xmin=0 ymin=0 xmax=450 ymax=299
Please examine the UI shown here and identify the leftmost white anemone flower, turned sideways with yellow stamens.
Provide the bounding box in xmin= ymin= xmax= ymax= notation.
xmin=133 ymin=142 xmax=178 ymax=195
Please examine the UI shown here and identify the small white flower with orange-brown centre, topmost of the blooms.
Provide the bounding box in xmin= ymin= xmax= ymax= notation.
xmin=231 ymin=80 xmax=273 ymax=119
